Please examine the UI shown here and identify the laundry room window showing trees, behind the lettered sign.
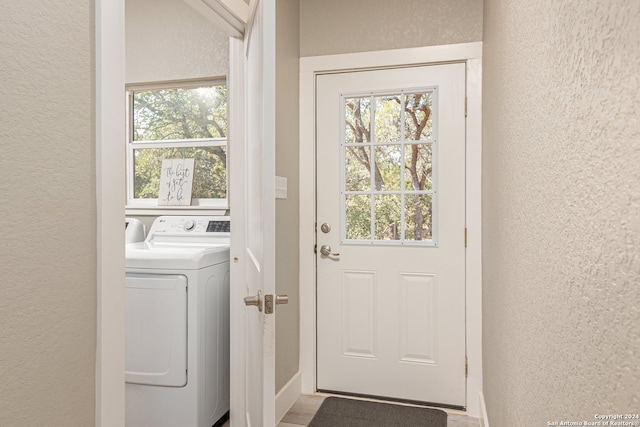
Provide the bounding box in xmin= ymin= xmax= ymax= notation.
xmin=127 ymin=80 xmax=228 ymax=208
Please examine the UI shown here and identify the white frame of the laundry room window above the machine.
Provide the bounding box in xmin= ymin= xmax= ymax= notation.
xmin=125 ymin=77 xmax=229 ymax=215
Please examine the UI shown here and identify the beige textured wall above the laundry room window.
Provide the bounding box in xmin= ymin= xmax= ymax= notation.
xmin=125 ymin=0 xmax=229 ymax=83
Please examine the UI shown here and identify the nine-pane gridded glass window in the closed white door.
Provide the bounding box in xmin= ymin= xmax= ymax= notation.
xmin=340 ymin=87 xmax=437 ymax=245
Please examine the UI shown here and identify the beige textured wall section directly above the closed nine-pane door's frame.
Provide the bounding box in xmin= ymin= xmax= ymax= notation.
xmin=300 ymin=0 xmax=482 ymax=56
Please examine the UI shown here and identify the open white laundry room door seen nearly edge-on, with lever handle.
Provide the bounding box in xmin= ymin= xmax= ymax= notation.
xmin=242 ymin=0 xmax=275 ymax=427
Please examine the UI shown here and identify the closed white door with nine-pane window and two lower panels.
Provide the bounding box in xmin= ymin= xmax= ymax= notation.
xmin=316 ymin=63 xmax=465 ymax=406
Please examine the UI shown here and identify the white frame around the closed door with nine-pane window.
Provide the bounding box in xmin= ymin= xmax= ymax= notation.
xmin=300 ymin=42 xmax=482 ymax=417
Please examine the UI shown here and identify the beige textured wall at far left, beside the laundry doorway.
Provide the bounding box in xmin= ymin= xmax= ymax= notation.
xmin=0 ymin=0 xmax=97 ymax=427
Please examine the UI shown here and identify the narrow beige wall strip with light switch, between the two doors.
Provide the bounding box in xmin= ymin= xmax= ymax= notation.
xmin=276 ymin=0 xmax=300 ymax=393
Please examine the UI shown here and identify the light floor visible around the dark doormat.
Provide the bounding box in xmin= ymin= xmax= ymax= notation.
xmin=223 ymin=394 xmax=480 ymax=427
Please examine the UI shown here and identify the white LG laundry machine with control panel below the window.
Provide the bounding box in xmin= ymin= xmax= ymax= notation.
xmin=125 ymin=216 xmax=230 ymax=427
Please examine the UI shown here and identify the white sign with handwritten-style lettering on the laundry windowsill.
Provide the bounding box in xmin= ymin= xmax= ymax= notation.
xmin=158 ymin=159 xmax=195 ymax=206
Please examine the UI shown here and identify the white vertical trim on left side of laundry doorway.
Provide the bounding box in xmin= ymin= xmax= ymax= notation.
xmin=95 ymin=0 xmax=125 ymax=427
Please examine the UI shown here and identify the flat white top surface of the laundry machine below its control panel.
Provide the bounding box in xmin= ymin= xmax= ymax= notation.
xmin=125 ymin=242 xmax=229 ymax=270
